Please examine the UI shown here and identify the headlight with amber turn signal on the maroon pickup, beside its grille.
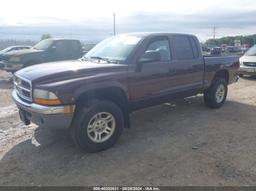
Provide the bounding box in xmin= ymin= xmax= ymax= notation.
xmin=33 ymin=89 xmax=61 ymax=105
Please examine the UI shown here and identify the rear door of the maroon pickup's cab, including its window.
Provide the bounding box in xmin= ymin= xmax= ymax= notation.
xmin=170 ymin=35 xmax=204 ymax=96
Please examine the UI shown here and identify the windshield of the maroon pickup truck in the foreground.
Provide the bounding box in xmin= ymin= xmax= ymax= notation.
xmin=83 ymin=35 xmax=141 ymax=63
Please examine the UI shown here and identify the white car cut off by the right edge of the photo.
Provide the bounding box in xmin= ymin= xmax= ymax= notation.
xmin=239 ymin=45 xmax=256 ymax=76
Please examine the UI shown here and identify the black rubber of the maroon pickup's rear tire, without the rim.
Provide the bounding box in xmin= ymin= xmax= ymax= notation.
xmin=204 ymin=78 xmax=228 ymax=109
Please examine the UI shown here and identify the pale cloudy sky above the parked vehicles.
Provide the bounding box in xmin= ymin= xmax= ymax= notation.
xmin=0 ymin=0 xmax=256 ymax=40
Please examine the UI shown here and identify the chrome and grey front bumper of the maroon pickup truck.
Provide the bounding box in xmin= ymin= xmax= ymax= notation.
xmin=12 ymin=90 xmax=75 ymax=128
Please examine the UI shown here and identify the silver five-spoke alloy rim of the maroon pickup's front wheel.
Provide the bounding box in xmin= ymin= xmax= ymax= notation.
xmin=87 ymin=112 xmax=116 ymax=143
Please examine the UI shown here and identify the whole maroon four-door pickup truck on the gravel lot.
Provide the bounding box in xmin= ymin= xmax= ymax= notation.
xmin=12 ymin=33 xmax=239 ymax=152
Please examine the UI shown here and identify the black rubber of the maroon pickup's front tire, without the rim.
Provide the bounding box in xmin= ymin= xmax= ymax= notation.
xmin=71 ymin=100 xmax=124 ymax=153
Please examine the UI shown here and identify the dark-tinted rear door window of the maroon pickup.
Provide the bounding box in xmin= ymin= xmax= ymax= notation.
xmin=172 ymin=36 xmax=194 ymax=60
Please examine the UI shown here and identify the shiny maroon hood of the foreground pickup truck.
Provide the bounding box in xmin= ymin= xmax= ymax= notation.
xmin=15 ymin=60 xmax=127 ymax=83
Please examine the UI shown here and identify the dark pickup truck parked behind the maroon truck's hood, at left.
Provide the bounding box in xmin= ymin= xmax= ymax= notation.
xmin=3 ymin=38 xmax=83 ymax=72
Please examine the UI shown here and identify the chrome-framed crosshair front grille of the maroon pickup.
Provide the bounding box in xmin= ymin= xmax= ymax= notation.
xmin=13 ymin=75 xmax=32 ymax=102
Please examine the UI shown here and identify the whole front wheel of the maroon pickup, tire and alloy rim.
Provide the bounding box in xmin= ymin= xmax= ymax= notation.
xmin=71 ymin=100 xmax=124 ymax=153
